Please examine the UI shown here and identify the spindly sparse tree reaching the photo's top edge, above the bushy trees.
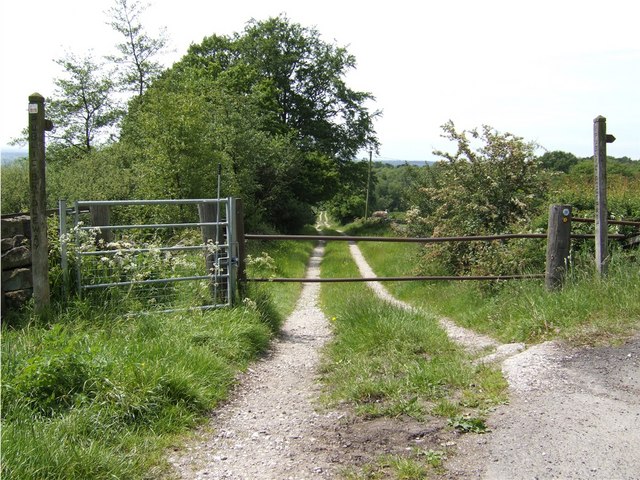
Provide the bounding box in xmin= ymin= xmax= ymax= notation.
xmin=108 ymin=0 xmax=167 ymax=98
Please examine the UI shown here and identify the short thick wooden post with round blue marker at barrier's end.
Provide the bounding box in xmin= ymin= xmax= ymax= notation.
xmin=545 ymin=205 xmax=571 ymax=290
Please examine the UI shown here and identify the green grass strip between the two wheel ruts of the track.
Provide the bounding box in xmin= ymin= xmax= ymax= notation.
xmin=321 ymin=242 xmax=506 ymax=419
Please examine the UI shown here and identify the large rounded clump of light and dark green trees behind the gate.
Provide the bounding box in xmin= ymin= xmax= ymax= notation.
xmin=121 ymin=17 xmax=377 ymax=232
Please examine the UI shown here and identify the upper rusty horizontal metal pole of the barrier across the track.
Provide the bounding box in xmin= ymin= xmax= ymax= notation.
xmin=244 ymin=233 xmax=547 ymax=243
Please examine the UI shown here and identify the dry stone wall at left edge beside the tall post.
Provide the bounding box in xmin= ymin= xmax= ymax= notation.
xmin=2 ymin=215 xmax=33 ymax=316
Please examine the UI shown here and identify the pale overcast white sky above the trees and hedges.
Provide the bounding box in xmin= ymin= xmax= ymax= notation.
xmin=0 ymin=0 xmax=640 ymax=160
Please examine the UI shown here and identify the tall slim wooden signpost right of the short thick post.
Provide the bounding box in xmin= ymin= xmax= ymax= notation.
xmin=593 ymin=116 xmax=616 ymax=276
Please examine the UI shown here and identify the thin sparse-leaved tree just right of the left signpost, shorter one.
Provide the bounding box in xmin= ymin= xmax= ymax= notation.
xmin=47 ymin=53 xmax=121 ymax=153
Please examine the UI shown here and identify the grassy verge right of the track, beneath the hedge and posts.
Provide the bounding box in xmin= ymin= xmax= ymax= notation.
xmin=359 ymin=222 xmax=640 ymax=344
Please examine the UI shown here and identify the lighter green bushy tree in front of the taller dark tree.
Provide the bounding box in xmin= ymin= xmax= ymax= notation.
xmin=121 ymin=74 xmax=322 ymax=231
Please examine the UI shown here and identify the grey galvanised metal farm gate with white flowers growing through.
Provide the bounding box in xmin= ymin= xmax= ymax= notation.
xmin=59 ymin=198 xmax=239 ymax=312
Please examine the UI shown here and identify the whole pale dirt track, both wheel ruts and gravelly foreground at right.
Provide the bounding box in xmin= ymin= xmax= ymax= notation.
xmin=170 ymin=240 xmax=640 ymax=480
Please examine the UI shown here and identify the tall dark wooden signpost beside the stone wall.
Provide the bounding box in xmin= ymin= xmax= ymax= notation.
xmin=29 ymin=93 xmax=51 ymax=313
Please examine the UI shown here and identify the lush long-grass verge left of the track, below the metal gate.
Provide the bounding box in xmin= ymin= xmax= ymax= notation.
xmin=2 ymin=238 xmax=312 ymax=480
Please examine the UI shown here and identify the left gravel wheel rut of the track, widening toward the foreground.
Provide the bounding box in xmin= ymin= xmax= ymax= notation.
xmin=170 ymin=245 xmax=340 ymax=479
